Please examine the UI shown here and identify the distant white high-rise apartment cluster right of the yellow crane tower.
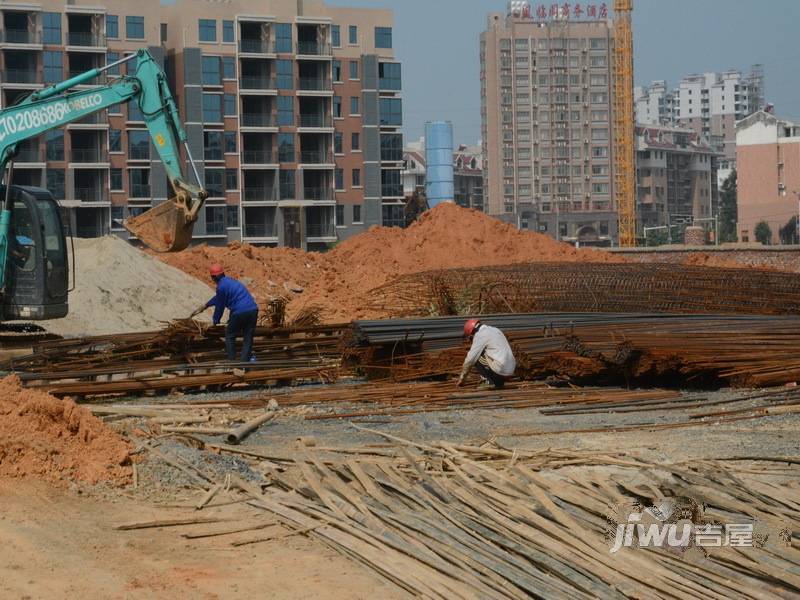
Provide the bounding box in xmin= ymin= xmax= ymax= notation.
xmin=634 ymin=65 xmax=765 ymax=163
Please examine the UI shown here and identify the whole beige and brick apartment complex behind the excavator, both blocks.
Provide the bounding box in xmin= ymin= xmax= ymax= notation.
xmin=0 ymin=0 xmax=403 ymax=249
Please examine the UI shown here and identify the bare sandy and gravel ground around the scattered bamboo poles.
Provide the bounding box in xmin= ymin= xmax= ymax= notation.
xmin=0 ymin=382 xmax=800 ymax=598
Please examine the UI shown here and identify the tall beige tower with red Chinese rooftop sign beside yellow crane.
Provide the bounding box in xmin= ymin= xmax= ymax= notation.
xmin=480 ymin=5 xmax=618 ymax=244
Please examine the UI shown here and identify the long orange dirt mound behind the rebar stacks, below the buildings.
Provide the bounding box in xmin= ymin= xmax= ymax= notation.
xmin=159 ymin=203 xmax=624 ymax=322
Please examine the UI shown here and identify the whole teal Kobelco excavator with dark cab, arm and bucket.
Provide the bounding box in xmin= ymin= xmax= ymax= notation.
xmin=0 ymin=49 xmax=208 ymax=323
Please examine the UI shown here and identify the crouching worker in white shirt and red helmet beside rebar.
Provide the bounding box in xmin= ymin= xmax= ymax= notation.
xmin=458 ymin=319 xmax=517 ymax=389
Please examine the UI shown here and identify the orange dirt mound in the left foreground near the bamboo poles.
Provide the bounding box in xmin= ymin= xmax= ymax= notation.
xmin=0 ymin=376 xmax=130 ymax=484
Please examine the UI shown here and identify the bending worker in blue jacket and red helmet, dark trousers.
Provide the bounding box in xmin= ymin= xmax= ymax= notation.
xmin=192 ymin=263 xmax=258 ymax=362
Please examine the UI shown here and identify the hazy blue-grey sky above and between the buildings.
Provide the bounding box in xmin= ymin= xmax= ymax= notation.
xmin=326 ymin=0 xmax=800 ymax=144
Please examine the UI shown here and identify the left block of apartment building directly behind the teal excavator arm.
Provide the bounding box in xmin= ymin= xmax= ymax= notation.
xmin=0 ymin=0 xmax=167 ymax=237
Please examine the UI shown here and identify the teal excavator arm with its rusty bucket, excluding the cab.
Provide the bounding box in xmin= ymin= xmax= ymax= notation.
xmin=0 ymin=49 xmax=208 ymax=289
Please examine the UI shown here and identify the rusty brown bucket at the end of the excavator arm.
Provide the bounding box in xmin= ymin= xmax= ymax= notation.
xmin=122 ymin=198 xmax=195 ymax=252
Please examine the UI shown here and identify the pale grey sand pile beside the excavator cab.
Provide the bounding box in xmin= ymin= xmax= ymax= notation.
xmin=42 ymin=236 xmax=214 ymax=337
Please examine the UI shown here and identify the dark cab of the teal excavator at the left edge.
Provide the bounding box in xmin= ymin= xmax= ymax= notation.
xmin=0 ymin=185 xmax=69 ymax=321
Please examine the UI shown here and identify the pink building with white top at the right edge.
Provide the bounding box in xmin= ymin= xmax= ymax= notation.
xmin=736 ymin=111 xmax=800 ymax=243
